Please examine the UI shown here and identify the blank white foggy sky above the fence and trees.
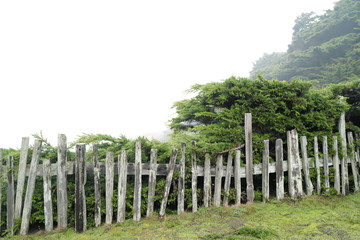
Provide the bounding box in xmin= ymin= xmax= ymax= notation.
xmin=0 ymin=0 xmax=335 ymax=148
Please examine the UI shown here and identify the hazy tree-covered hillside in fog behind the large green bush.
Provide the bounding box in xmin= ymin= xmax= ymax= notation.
xmin=250 ymin=0 xmax=360 ymax=84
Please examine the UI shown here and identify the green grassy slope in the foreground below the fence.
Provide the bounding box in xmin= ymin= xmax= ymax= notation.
xmin=7 ymin=193 xmax=360 ymax=240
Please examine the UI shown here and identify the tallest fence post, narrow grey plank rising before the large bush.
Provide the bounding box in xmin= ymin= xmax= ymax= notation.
xmin=245 ymin=113 xmax=255 ymax=203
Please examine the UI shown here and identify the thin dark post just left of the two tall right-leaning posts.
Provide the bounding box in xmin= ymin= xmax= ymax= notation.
xmin=6 ymin=156 xmax=15 ymax=235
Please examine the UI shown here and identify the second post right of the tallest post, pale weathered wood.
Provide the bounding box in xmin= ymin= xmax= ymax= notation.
xmin=275 ymin=139 xmax=285 ymax=200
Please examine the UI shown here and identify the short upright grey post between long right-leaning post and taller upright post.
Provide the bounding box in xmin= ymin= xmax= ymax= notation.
xmin=43 ymin=159 xmax=54 ymax=232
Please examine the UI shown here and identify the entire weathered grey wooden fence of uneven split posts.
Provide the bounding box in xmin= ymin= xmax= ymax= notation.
xmin=0 ymin=113 xmax=360 ymax=235
